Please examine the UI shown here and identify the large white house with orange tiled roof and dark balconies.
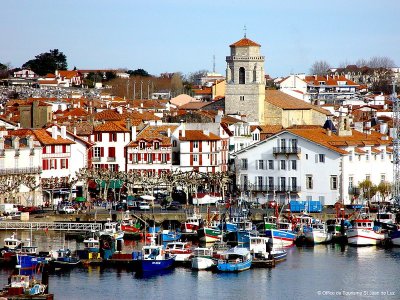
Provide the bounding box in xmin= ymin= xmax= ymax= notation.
xmin=235 ymin=118 xmax=393 ymax=205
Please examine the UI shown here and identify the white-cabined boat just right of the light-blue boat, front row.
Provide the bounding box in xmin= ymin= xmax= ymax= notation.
xmin=249 ymin=236 xmax=287 ymax=262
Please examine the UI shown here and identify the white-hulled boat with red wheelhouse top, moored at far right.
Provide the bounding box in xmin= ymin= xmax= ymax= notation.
xmin=346 ymin=219 xmax=386 ymax=246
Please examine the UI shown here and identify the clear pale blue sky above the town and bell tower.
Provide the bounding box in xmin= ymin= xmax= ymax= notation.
xmin=0 ymin=0 xmax=400 ymax=77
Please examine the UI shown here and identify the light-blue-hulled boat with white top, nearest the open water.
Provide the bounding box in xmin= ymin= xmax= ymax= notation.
xmin=217 ymin=247 xmax=252 ymax=272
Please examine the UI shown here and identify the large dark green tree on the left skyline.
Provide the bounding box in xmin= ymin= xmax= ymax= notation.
xmin=22 ymin=49 xmax=68 ymax=76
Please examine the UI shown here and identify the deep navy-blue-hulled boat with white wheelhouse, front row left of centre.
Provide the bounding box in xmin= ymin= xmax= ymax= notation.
xmin=138 ymin=236 xmax=176 ymax=272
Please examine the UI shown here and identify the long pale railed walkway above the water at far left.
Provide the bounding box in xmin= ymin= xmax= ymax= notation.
xmin=0 ymin=221 xmax=103 ymax=231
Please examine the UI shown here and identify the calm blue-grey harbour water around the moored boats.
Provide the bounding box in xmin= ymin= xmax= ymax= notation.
xmin=0 ymin=232 xmax=400 ymax=300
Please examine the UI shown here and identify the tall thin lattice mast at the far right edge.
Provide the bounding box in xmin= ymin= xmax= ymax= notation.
xmin=391 ymin=80 xmax=400 ymax=204
